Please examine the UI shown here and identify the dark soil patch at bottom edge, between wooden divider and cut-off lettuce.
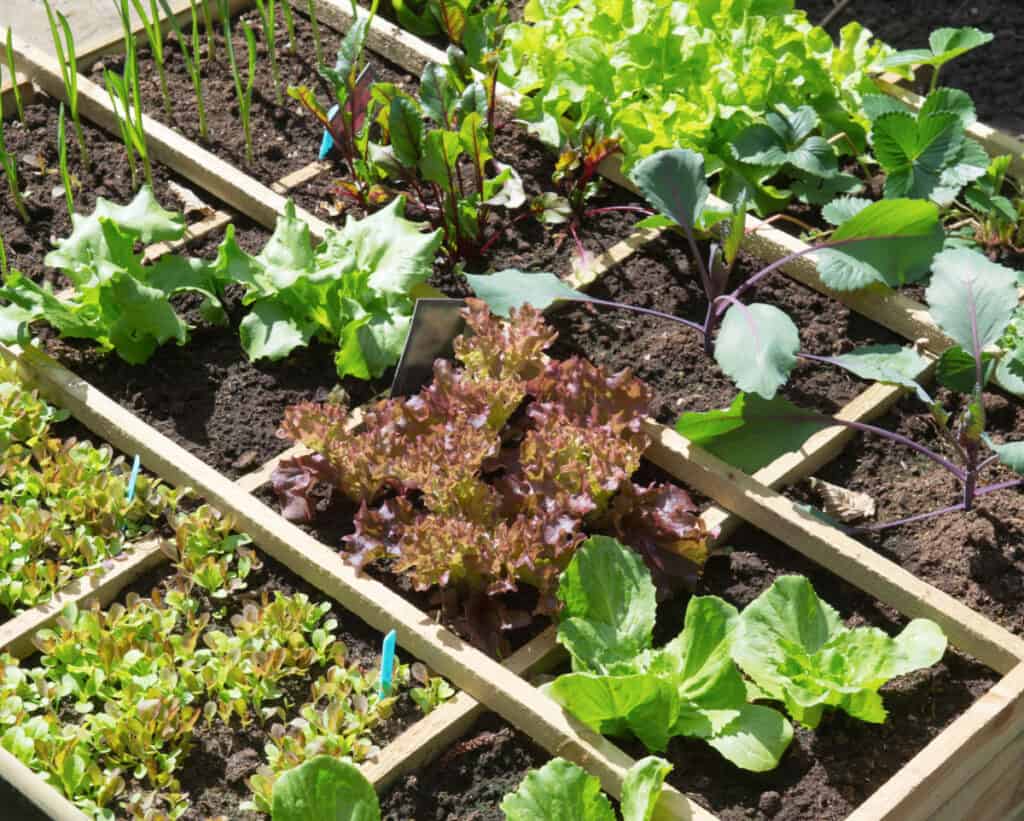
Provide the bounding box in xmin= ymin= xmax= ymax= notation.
xmin=381 ymin=714 xmax=552 ymax=821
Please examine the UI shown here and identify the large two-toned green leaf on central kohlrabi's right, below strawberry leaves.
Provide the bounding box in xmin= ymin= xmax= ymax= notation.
xmin=811 ymin=200 xmax=944 ymax=291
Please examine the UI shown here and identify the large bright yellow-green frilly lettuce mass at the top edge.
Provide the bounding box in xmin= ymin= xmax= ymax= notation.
xmin=501 ymin=0 xmax=889 ymax=178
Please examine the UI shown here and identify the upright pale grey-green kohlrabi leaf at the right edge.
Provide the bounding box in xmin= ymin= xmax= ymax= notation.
xmin=926 ymin=249 xmax=1017 ymax=357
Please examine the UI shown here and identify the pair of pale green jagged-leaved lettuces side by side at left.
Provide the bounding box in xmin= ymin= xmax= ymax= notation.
xmin=0 ymin=187 xmax=441 ymax=379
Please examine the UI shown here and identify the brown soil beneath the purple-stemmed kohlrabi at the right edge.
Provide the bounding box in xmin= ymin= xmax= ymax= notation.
xmin=794 ymin=386 xmax=1024 ymax=634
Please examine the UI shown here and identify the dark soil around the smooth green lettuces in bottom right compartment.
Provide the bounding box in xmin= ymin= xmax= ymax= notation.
xmin=623 ymin=527 xmax=998 ymax=821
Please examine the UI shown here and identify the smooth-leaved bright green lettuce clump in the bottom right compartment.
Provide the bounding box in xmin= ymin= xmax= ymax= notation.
xmin=544 ymin=536 xmax=946 ymax=772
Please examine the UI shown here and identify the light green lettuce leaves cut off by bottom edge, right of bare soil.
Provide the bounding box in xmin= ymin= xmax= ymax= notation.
xmin=502 ymin=755 xmax=672 ymax=821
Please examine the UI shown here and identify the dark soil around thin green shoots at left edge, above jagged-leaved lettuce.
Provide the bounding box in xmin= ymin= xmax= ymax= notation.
xmin=0 ymin=96 xmax=219 ymax=286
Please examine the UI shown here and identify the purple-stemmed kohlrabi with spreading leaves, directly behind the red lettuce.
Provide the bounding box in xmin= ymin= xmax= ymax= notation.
xmin=468 ymin=148 xmax=943 ymax=399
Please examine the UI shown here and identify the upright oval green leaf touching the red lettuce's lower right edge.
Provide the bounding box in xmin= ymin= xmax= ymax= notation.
xmin=558 ymin=535 xmax=657 ymax=673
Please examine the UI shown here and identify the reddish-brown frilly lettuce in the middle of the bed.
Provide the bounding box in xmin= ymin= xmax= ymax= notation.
xmin=273 ymin=300 xmax=707 ymax=645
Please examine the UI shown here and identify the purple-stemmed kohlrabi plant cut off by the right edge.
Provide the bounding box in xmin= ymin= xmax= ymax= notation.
xmin=677 ymin=249 xmax=1024 ymax=530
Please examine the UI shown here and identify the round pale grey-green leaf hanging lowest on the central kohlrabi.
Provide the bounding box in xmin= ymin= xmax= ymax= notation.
xmin=715 ymin=303 xmax=800 ymax=399
